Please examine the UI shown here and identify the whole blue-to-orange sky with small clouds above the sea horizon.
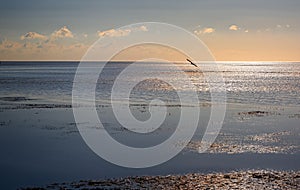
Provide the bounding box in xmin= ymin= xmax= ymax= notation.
xmin=0 ymin=0 xmax=300 ymax=61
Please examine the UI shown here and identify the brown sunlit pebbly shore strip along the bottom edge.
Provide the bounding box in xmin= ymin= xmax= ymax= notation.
xmin=25 ymin=170 xmax=300 ymax=189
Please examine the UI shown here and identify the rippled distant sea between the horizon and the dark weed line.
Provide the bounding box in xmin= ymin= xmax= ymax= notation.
xmin=0 ymin=62 xmax=300 ymax=105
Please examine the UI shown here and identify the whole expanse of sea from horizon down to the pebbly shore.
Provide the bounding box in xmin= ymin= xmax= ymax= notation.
xmin=0 ymin=62 xmax=300 ymax=189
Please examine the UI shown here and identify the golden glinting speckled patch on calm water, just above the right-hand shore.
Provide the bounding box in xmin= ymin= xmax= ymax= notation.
xmin=175 ymin=131 xmax=300 ymax=154
